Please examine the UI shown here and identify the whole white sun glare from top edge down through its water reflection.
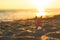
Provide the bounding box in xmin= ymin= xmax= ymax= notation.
xmin=29 ymin=0 xmax=54 ymax=16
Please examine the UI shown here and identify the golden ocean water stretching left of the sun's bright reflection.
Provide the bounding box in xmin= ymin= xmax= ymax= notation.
xmin=0 ymin=11 xmax=36 ymax=20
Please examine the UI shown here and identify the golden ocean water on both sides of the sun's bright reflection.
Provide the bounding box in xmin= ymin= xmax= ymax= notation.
xmin=0 ymin=9 xmax=60 ymax=20
